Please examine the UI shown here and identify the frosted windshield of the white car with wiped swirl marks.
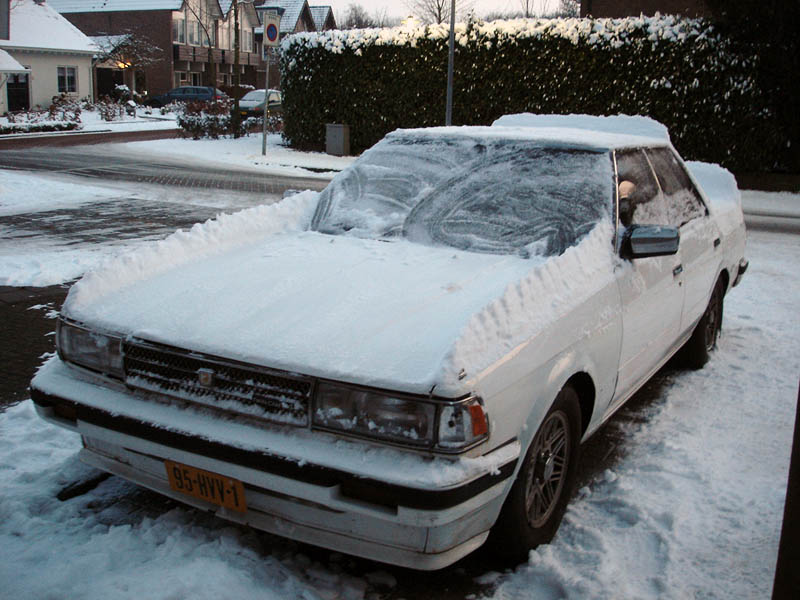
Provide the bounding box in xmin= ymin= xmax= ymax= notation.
xmin=312 ymin=131 xmax=613 ymax=257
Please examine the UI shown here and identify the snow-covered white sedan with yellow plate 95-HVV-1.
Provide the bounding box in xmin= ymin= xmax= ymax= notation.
xmin=31 ymin=115 xmax=747 ymax=569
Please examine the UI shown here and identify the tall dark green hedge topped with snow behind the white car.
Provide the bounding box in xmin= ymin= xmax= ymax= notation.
xmin=281 ymin=15 xmax=788 ymax=170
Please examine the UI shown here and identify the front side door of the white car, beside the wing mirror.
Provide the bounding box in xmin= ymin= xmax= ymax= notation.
xmin=610 ymin=148 xmax=684 ymax=410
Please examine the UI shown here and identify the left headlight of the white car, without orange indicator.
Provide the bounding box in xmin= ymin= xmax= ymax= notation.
xmin=56 ymin=319 xmax=125 ymax=379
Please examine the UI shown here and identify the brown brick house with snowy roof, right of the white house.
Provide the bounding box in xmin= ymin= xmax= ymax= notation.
xmin=49 ymin=0 xmax=264 ymax=95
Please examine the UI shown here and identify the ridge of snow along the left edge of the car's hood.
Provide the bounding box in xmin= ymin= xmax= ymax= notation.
xmin=64 ymin=191 xmax=318 ymax=313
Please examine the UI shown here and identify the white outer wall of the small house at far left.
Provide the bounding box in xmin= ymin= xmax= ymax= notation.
xmin=0 ymin=48 xmax=94 ymax=114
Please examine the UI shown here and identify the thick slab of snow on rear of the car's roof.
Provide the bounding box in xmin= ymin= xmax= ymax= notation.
xmin=492 ymin=113 xmax=669 ymax=141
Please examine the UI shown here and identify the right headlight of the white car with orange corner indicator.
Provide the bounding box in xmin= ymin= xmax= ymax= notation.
xmin=312 ymin=383 xmax=489 ymax=452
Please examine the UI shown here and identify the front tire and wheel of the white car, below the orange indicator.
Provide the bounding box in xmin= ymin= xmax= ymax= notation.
xmin=489 ymin=385 xmax=581 ymax=562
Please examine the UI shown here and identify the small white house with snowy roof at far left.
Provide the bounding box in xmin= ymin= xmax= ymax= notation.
xmin=0 ymin=0 xmax=97 ymax=114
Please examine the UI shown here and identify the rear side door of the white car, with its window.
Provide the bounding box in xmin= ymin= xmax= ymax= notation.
xmin=646 ymin=148 xmax=720 ymax=332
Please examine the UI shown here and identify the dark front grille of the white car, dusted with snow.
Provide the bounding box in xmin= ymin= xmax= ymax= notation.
xmin=123 ymin=341 xmax=312 ymax=426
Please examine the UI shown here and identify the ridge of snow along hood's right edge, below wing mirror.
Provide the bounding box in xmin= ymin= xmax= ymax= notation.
xmin=442 ymin=220 xmax=617 ymax=382
